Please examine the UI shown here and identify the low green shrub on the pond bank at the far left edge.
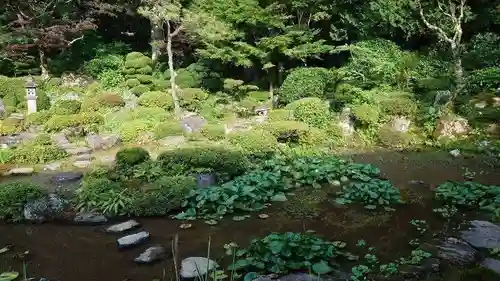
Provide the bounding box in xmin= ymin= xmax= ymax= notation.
xmin=0 ymin=181 xmax=43 ymax=221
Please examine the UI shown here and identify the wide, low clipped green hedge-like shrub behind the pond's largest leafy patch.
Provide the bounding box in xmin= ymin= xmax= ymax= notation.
xmin=157 ymin=146 xmax=250 ymax=178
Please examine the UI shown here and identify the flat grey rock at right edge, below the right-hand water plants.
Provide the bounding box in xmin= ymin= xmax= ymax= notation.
xmin=460 ymin=220 xmax=500 ymax=249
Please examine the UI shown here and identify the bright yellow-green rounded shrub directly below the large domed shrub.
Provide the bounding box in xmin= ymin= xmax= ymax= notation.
xmin=285 ymin=98 xmax=332 ymax=128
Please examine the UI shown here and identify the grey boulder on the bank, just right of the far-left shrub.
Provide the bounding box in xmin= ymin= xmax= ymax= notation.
xmin=23 ymin=193 xmax=70 ymax=222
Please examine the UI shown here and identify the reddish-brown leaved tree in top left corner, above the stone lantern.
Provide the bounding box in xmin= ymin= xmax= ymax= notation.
xmin=5 ymin=0 xmax=96 ymax=78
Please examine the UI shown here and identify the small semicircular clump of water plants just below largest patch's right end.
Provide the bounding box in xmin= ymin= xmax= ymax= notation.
xmin=336 ymin=177 xmax=402 ymax=210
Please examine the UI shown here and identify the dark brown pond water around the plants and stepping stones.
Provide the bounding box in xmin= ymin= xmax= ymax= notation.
xmin=0 ymin=152 xmax=500 ymax=281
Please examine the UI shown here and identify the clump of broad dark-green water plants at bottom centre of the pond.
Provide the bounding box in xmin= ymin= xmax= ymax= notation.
xmin=229 ymin=232 xmax=347 ymax=275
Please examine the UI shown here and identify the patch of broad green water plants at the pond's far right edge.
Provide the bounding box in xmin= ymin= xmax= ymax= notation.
xmin=434 ymin=181 xmax=500 ymax=217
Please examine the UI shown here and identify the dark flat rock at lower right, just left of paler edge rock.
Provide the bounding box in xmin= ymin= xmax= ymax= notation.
xmin=437 ymin=237 xmax=478 ymax=266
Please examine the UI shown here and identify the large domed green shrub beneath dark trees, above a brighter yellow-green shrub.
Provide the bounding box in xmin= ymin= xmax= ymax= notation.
xmin=279 ymin=67 xmax=331 ymax=104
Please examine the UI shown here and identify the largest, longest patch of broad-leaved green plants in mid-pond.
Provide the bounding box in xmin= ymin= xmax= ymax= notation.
xmin=178 ymin=156 xmax=380 ymax=219
